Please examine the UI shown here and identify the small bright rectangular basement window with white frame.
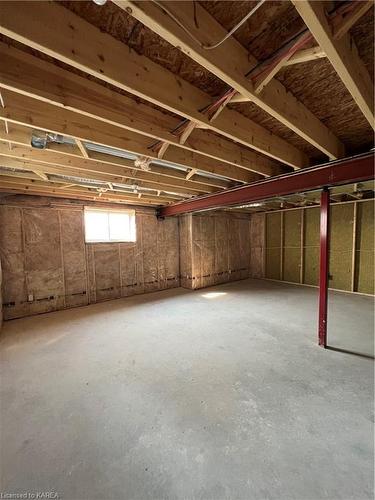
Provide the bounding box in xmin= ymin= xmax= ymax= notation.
xmin=85 ymin=208 xmax=136 ymax=243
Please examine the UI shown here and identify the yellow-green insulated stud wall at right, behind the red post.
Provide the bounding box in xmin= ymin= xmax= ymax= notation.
xmin=262 ymin=200 xmax=374 ymax=294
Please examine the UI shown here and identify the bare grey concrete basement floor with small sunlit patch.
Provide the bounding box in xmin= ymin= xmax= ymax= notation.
xmin=0 ymin=280 xmax=374 ymax=500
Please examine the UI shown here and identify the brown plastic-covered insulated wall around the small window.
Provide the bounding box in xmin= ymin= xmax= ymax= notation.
xmin=0 ymin=196 xmax=179 ymax=319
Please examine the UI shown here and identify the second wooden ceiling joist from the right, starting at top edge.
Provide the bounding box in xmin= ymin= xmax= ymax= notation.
xmin=114 ymin=0 xmax=344 ymax=159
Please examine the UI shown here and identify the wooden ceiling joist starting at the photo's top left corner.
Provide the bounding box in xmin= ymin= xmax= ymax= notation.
xmin=0 ymin=1 xmax=308 ymax=168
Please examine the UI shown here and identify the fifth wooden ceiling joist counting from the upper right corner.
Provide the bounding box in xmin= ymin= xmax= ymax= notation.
xmin=0 ymin=90 xmax=260 ymax=182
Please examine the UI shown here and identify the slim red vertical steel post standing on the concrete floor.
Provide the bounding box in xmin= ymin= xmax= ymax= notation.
xmin=319 ymin=188 xmax=329 ymax=347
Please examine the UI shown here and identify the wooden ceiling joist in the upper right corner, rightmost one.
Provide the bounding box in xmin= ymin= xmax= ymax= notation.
xmin=292 ymin=0 xmax=374 ymax=128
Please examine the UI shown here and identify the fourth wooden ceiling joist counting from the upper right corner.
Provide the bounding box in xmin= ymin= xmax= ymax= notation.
xmin=0 ymin=43 xmax=281 ymax=180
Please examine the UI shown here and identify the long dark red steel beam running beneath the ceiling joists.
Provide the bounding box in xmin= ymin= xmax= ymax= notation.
xmin=158 ymin=152 xmax=374 ymax=217
